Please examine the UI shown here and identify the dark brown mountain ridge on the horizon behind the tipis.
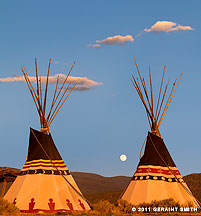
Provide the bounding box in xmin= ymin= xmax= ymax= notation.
xmin=0 ymin=167 xmax=201 ymax=203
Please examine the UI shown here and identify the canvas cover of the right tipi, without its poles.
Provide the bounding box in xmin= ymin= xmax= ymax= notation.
xmin=121 ymin=132 xmax=198 ymax=206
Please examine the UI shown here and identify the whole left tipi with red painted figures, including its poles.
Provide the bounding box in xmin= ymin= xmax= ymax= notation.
xmin=4 ymin=59 xmax=91 ymax=213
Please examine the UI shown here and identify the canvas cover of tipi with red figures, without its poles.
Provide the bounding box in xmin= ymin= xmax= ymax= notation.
xmin=4 ymin=128 xmax=90 ymax=213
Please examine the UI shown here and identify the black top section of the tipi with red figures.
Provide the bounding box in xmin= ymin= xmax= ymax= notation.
xmin=26 ymin=128 xmax=62 ymax=161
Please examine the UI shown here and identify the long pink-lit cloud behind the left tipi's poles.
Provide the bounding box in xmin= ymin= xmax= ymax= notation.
xmin=0 ymin=74 xmax=103 ymax=91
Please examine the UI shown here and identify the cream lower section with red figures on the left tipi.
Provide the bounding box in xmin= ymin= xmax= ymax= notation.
xmin=4 ymin=174 xmax=90 ymax=213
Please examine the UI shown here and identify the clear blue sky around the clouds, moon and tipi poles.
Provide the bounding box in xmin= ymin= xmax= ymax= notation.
xmin=0 ymin=0 xmax=201 ymax=176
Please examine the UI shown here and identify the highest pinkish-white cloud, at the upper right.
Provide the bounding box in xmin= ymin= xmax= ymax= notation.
xmin=144 ymin=21 xmax=194 ymax=32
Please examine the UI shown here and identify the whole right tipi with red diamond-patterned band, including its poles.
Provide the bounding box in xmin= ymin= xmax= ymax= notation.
xmin=120 ymin=58 xmax=199 ymax=207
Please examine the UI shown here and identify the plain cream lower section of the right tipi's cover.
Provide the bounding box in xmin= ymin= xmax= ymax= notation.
xmin=121 ymin=180 xmax=197 ymax=207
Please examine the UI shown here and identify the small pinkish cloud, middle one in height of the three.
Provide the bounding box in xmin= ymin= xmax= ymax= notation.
xmin=96 ymin=35 xmax=134 ymax=45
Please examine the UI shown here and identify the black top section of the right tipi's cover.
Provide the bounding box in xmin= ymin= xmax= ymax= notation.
xmin=138 ymin=132 xmax=176 ymax=167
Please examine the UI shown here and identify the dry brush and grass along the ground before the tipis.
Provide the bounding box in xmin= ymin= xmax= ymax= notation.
xmin=0 ymin=199 xmax=201 ymax=216
